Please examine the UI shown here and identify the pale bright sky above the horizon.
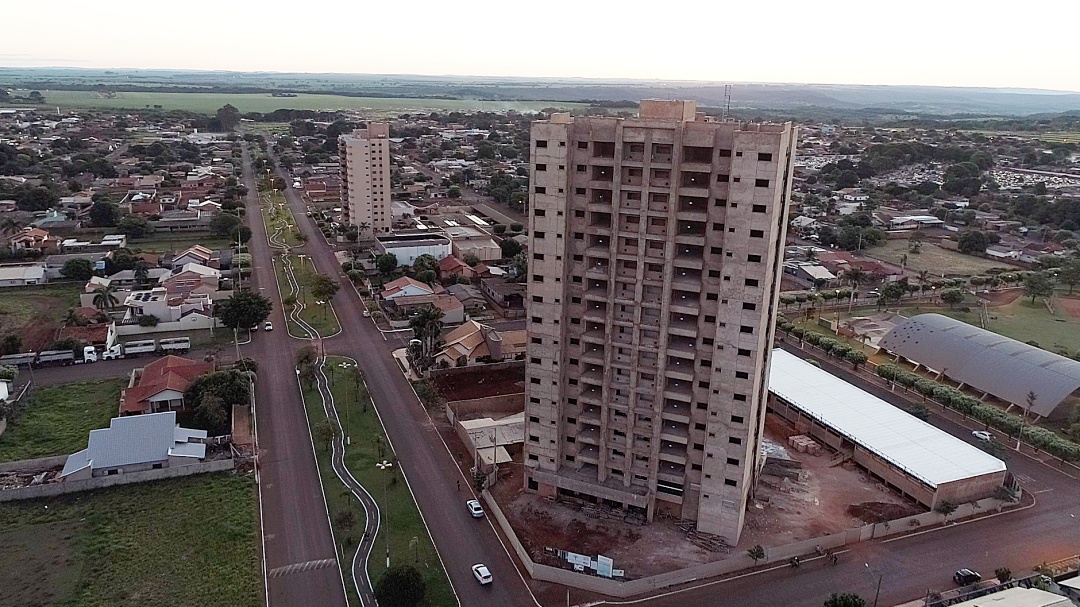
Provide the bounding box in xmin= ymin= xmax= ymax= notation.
xmin=6 ymin=0 xmax=1080 ymax=91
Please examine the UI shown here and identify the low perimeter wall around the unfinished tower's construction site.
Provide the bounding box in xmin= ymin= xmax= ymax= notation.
xmin=482 ymin=490 xmax=1002 ymax=598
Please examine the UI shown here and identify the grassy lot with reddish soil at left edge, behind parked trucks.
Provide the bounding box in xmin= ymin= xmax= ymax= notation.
xmin=0 ymin=283 xmax=83 ymax=351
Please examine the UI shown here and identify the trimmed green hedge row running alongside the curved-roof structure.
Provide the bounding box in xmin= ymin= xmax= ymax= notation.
xmin=877 ymin=363 xmax=1080 ymax=461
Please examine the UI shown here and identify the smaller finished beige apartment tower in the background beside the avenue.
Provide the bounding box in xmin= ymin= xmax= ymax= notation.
xmin=338 ymin=122 xmax=393 ymax=235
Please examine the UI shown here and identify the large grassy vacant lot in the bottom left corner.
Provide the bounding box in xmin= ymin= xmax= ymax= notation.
xmin=0 ymin=473 xmax=264 ymax=607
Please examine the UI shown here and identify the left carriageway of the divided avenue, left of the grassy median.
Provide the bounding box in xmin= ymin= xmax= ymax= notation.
xmin=244 ymin=145 xmax=346 ymax=607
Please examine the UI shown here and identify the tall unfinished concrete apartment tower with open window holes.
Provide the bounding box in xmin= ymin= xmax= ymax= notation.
xmin=525 ymin=100 xmax=796 ymax=537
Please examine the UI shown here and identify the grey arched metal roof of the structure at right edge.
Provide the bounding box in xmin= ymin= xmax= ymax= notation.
xmin=881 ymin=314 xmax=1080 ymax=417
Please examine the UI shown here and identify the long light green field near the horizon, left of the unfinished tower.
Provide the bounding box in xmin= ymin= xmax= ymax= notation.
xmin=27 ymin=91 xmax=582 ymax=114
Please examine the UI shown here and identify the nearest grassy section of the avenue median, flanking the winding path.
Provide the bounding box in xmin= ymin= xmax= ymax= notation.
xmin=305 ymin=356 xmax=457 ymax=607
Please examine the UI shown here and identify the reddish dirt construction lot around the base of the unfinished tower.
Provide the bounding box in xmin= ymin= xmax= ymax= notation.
xmin=486 ymin=416 xmax=923 ymax=578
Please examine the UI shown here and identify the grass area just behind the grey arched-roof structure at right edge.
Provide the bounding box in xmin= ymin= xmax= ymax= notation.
xmin=900 ymin=297 xmax=1080 ymax=353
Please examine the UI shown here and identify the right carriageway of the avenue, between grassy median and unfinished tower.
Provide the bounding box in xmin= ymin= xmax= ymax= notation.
xmin=272 ymin=162 xmax=534 ymax=606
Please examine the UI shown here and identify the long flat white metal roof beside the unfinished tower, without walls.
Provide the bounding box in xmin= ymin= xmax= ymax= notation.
xmin=769 ymin=349 xmax=1005 ymax=488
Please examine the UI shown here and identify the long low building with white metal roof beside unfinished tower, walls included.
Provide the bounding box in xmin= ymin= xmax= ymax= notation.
xmin=769 ymin=349 xmax=1005 ymax=508
